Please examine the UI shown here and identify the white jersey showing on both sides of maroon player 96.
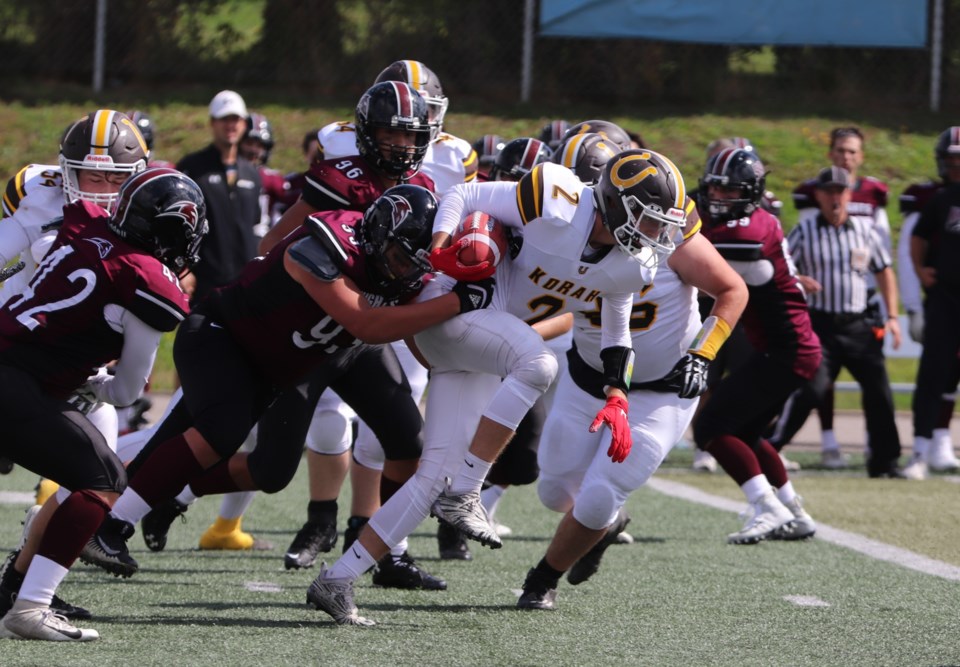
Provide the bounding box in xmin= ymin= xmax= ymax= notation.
xmin=317 ymin=121 xmax=478 ymax=195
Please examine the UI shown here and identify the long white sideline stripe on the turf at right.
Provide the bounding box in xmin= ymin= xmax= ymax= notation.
xmin=647 ymin=478 xmax=960 ymax=581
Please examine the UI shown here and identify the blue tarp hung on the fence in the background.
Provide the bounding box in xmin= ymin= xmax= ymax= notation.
xmin=539 ymin=0 xmax=927 ymax=48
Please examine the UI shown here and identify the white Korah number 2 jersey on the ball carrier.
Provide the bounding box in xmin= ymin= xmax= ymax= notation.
xmin=434 ymin=163 xmax=683 ymax=348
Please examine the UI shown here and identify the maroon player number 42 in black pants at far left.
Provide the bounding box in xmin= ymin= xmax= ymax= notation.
xmin=0 ymin=167 xmax=207 ymax=641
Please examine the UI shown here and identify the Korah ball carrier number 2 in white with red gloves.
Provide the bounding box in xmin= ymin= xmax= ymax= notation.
xmin=307 ymin=151 xmax=738 ymax=625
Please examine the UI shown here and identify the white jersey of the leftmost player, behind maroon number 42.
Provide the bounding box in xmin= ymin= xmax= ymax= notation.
xmin=0 ymin=164 xmax=64 ymax=303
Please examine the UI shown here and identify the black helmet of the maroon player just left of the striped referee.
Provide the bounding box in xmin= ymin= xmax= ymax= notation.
xmin=697 ymin=148 xmax=767 ymax=222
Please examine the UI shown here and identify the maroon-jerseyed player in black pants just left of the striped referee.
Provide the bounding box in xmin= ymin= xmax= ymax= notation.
xmin=694 ymin=148 xmax=821 ymax=544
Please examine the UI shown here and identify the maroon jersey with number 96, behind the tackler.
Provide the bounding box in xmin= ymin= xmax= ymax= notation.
xmin=301 ymin=155 xmax=436 ymax=211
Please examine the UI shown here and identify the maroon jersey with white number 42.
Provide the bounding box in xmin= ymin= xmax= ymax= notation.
xmin=0 ymin=201 xmax=188 ymax=398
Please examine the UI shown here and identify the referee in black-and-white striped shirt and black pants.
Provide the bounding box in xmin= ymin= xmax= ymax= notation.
xmin=771 ymin=167 xmax=905 ymax=479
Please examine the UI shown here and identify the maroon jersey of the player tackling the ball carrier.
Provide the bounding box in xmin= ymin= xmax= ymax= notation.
xmin=197 ymin=211 xmax=410 ymax=387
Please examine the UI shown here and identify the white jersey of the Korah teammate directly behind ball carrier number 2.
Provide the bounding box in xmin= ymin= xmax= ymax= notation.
xmin=573 ymin=262 xmax=701 ymax=384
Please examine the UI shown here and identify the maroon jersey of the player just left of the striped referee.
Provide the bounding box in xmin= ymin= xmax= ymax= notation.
xmin=700 ymin=209 xmax=821 ymax=379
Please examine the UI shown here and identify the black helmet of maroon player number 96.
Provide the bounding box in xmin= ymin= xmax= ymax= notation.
xmin=356 ymin=81 xmax=431 ymax=179
